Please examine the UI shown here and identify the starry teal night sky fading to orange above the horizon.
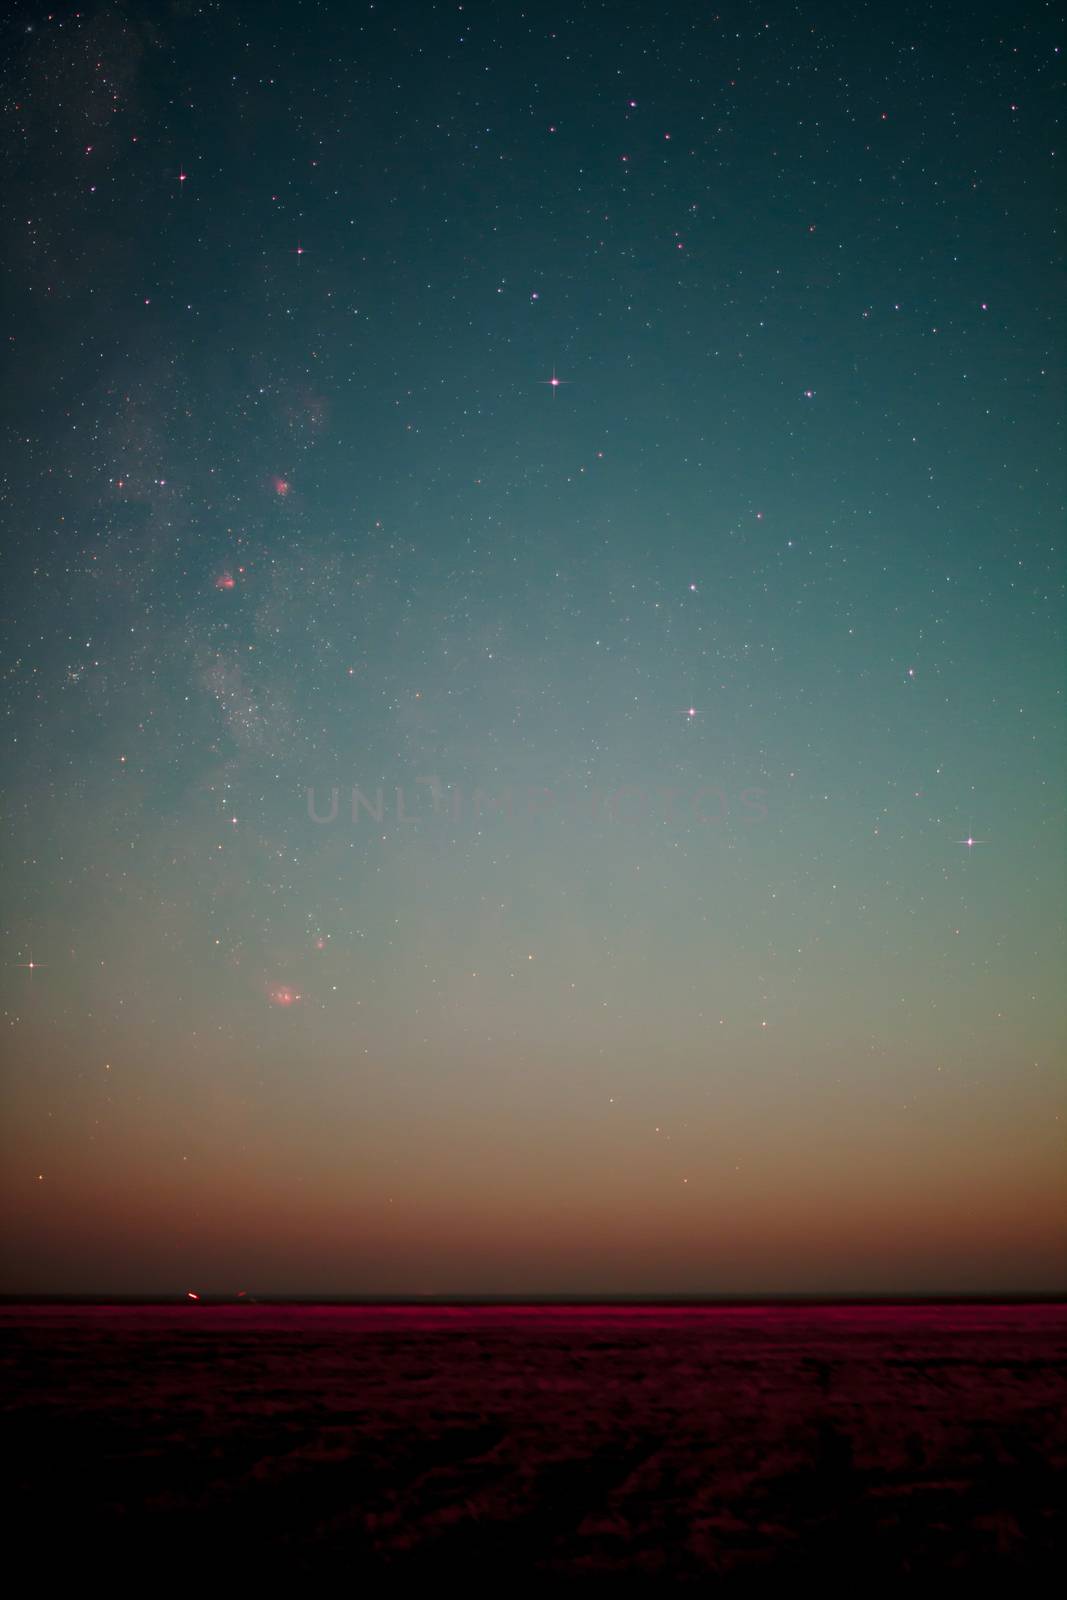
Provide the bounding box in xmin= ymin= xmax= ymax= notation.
xmin=0 ymin=0 xmax=1067 ymax=1296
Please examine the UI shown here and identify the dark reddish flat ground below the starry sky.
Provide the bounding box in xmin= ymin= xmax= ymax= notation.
xmin=0 ymin=1304 xmax=1067 ymax=1594
